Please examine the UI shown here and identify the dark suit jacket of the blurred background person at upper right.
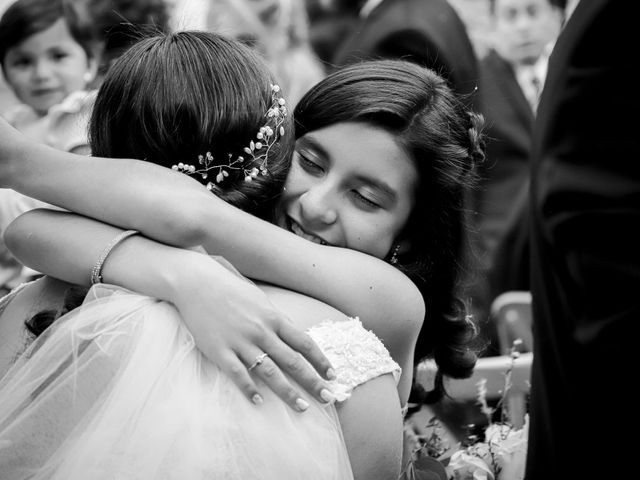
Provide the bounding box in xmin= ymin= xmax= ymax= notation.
xmin=474 ymin=50 xmax=534 ymax=326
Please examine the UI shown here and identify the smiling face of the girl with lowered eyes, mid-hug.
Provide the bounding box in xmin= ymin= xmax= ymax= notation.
xmin=277 ymin=123 xmax=418 ymax=258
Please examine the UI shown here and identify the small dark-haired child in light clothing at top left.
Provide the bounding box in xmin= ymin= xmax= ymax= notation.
xmin=0 ymin=0 xmax=97 ymax=153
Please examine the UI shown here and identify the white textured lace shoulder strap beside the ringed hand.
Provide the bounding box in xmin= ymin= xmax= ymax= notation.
xmin=308 ymin=318 xmax=402 ymax=401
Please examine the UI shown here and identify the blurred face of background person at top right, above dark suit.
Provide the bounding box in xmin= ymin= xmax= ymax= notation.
xmin=495 ymin=0 xmax=562 ymax=65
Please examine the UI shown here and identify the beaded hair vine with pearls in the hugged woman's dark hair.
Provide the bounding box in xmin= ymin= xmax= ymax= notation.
xmin=171 ymin=85 xmax=287 ymax=190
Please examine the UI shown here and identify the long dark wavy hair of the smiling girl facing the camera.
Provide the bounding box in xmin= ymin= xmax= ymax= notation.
xmin=294 ymin=60 xmax=484 ymax=401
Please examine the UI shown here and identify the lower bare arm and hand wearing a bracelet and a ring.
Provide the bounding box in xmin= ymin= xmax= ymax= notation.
xmin=6 ymin=209 xmax=330 ymax=410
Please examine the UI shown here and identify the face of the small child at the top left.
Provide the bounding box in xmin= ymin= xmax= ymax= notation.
xmin=4 ymin=18 xmax=95 ymax=115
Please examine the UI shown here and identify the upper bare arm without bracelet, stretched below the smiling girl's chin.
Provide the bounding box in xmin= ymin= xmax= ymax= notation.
xmin=0 ymin=118 xmax=424 ymax=374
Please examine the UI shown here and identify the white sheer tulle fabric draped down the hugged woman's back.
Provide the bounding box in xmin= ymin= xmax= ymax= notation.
xmin=0 ymin=286 xmax=353 ymax=480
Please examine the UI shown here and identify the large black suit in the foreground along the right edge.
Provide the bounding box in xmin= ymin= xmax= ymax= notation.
xmin=525 ymin=0 xmax=640 ymax=480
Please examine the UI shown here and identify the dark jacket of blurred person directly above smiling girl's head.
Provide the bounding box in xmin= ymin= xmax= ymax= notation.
xmin=333 ymin=0 xmax=478 ymax=108
